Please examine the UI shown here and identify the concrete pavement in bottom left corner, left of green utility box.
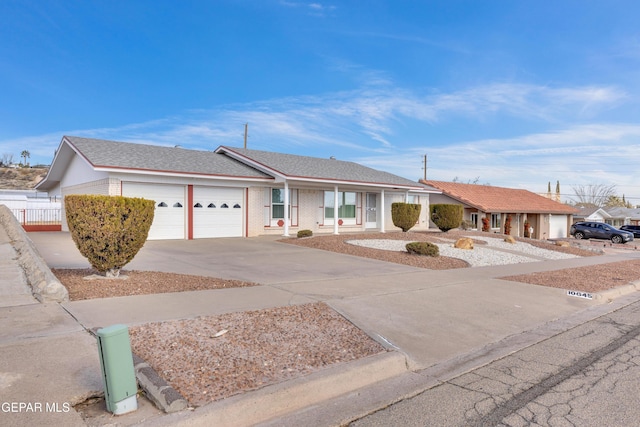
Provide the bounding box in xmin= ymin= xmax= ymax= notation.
xmin=0 ymin=227 xmax=102 ymax=426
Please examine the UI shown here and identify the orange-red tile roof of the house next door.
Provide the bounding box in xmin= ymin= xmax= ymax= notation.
xmin=420 ymin=179 xmax=578 ymax=215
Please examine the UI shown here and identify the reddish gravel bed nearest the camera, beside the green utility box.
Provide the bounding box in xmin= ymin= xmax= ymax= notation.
xmin=130 ymin=303 xmax=384 ymax=406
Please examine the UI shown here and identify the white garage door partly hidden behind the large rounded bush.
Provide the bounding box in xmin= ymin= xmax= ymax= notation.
xmin=122 ymin=182 xmax=187 ymax=240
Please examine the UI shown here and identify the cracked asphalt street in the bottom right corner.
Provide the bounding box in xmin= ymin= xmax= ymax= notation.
xmin=350 ymin=302 xmax=640 ymax=427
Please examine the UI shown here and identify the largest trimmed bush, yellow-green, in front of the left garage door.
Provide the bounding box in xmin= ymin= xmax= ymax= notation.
xmin=64 ymin=195 xmax=155 ymax=277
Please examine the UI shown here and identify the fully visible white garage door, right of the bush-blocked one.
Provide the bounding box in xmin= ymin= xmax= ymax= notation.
xmin=193 ymin=186 xmax=244 ymax=239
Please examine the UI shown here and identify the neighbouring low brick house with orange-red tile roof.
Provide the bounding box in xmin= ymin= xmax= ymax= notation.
xmin=420 ymin=180 xmax=577 ymax=239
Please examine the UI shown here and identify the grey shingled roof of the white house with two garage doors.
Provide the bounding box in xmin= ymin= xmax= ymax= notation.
xmin=37 ymin=136 xmax=436 ymax=192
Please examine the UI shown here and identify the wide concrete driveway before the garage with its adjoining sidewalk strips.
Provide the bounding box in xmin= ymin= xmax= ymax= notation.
xmin=29 ymin=233 xmax=640 ymax=369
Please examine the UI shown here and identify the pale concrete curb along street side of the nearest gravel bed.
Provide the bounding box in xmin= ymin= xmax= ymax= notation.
xmin=142 ymin=351 xmax=409 ymax=427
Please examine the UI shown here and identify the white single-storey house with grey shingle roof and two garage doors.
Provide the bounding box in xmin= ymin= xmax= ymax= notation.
xmin=37 ymin=136 xmax=438 ymax=239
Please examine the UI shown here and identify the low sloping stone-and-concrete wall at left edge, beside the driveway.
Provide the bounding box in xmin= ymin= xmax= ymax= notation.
xmin=0 ymin=205 xmax=69 ymax=302
